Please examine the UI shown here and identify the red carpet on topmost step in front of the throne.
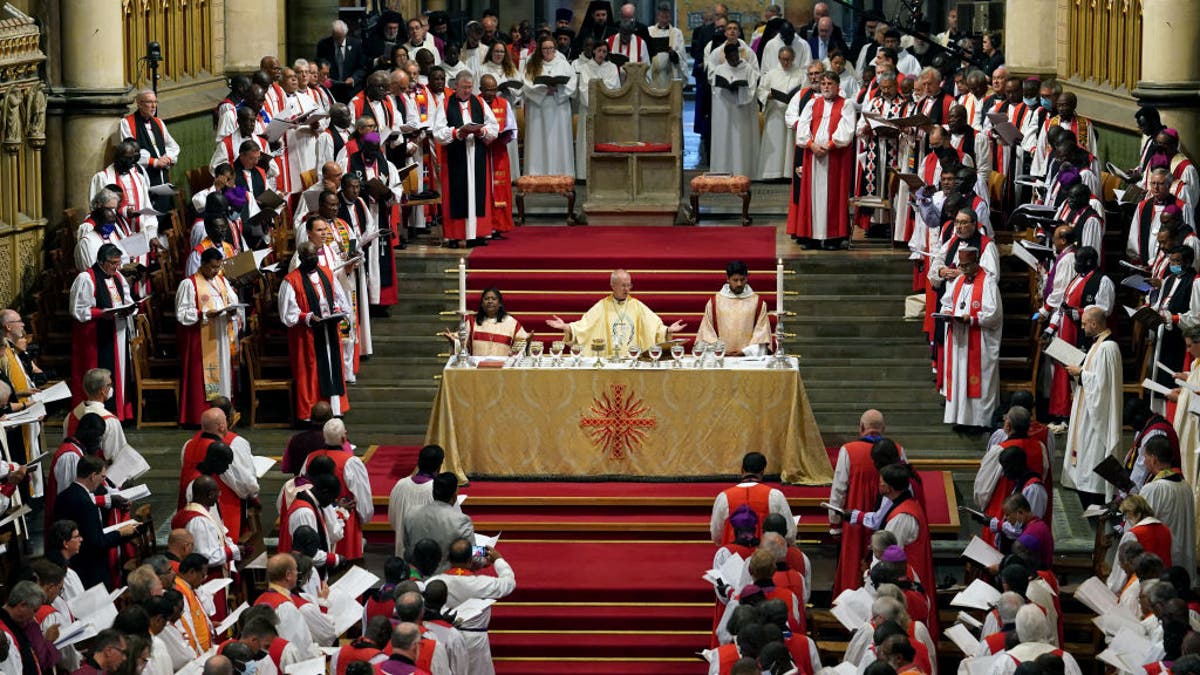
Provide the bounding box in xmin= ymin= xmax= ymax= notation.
xmin=468 ymin=226 xmax=775 ymax=269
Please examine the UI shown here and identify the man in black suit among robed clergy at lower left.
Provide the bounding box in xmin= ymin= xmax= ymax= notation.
xmin=54 ymin=455 xmax=138 ymax=589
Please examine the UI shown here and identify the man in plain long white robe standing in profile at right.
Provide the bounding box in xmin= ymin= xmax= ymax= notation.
xmin=1062 ymin=305 xmax=1122 ymax=507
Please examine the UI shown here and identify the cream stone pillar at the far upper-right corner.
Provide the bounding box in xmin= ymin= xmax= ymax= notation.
xmin=1133 ymin=0 xmax=1200 ymax=153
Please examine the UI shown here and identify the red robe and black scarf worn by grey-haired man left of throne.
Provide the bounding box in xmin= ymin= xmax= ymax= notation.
xmin=440 ymin=95 xmax=494 ymax=240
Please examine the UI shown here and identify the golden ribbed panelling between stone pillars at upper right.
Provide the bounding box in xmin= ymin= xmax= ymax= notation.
xmin=1067 ymin=0 xmax=1141 ymax=90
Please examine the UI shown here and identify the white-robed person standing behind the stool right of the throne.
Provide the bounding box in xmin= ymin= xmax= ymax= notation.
xmin=708 ymin=44 xmax=758 ymax=177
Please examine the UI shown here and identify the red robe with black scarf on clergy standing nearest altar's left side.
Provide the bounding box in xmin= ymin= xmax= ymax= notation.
xmin=283 ymin=267 xmax=350 ymax=419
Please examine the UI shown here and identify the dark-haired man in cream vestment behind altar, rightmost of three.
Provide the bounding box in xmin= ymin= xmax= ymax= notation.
xmin=696 ymin=261 xmax=770 ymax=357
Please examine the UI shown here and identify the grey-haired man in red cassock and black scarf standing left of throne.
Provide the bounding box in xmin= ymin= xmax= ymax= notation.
xmin=433 ymin=71 xmax=498 ymax=245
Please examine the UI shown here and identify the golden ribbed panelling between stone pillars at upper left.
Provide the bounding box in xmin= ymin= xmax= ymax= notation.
xmin=121 ymin=0 xmax=217 ymax=88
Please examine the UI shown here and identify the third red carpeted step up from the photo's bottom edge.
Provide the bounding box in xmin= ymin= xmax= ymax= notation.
xmin=491 ymin=602 xmax=714 ymax=631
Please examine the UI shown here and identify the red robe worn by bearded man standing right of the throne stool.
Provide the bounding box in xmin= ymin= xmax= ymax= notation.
xmin=787 ymin=96 xmax=854 ymax=239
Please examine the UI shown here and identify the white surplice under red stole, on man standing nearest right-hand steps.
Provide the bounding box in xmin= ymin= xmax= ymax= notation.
xmin=941 ymin=270 xmax=1004 ymax=426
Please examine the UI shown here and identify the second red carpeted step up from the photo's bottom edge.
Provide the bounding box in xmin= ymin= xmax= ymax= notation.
xmin=488 ymin=629 xmax=709 ymax=658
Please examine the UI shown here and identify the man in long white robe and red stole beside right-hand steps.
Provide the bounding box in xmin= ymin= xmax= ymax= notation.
xmin=941 ymin=247 xmax=1004 ymax=426
